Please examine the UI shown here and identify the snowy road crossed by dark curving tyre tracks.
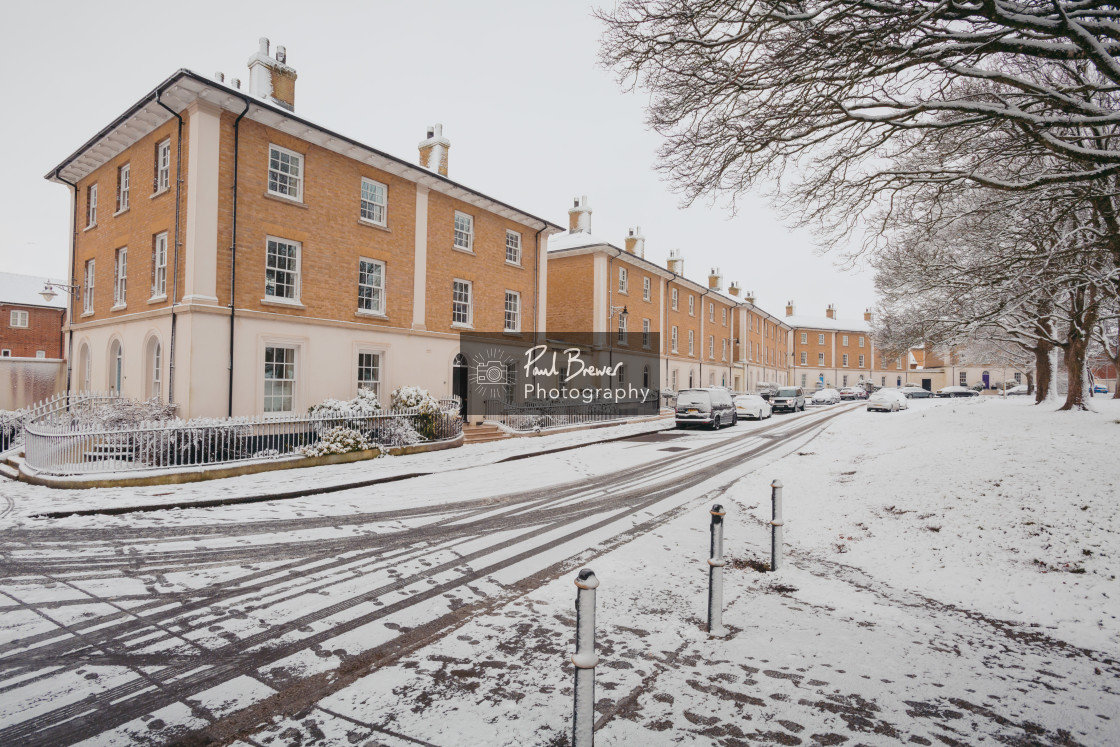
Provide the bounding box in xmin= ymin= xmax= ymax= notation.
xmin=0 ymin=407 xmax=850 ymax=745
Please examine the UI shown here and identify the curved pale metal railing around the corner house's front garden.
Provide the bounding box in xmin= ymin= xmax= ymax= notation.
xmin=24 ymin=401 xmax=463 ymax=475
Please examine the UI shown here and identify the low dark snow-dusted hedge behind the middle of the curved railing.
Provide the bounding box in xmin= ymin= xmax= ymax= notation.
xmin=132 ymin=418 xmax=252 ymax=467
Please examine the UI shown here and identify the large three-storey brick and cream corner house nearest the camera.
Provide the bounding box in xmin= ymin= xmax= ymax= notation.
xmin=47 ymin=39 xmax=561 ymax=417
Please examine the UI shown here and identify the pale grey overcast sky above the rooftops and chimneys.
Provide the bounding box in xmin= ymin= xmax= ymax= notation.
xmin=0 ymin=0 xmax=875 ymax=318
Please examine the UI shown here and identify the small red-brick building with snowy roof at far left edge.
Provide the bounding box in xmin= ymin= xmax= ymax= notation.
xmin=0 ymin=272 xmax=66 ymax=361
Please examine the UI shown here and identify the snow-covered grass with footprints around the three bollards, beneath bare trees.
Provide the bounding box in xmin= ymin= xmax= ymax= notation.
xmin=253 ymin=398 xmax=1120 ymax=745
